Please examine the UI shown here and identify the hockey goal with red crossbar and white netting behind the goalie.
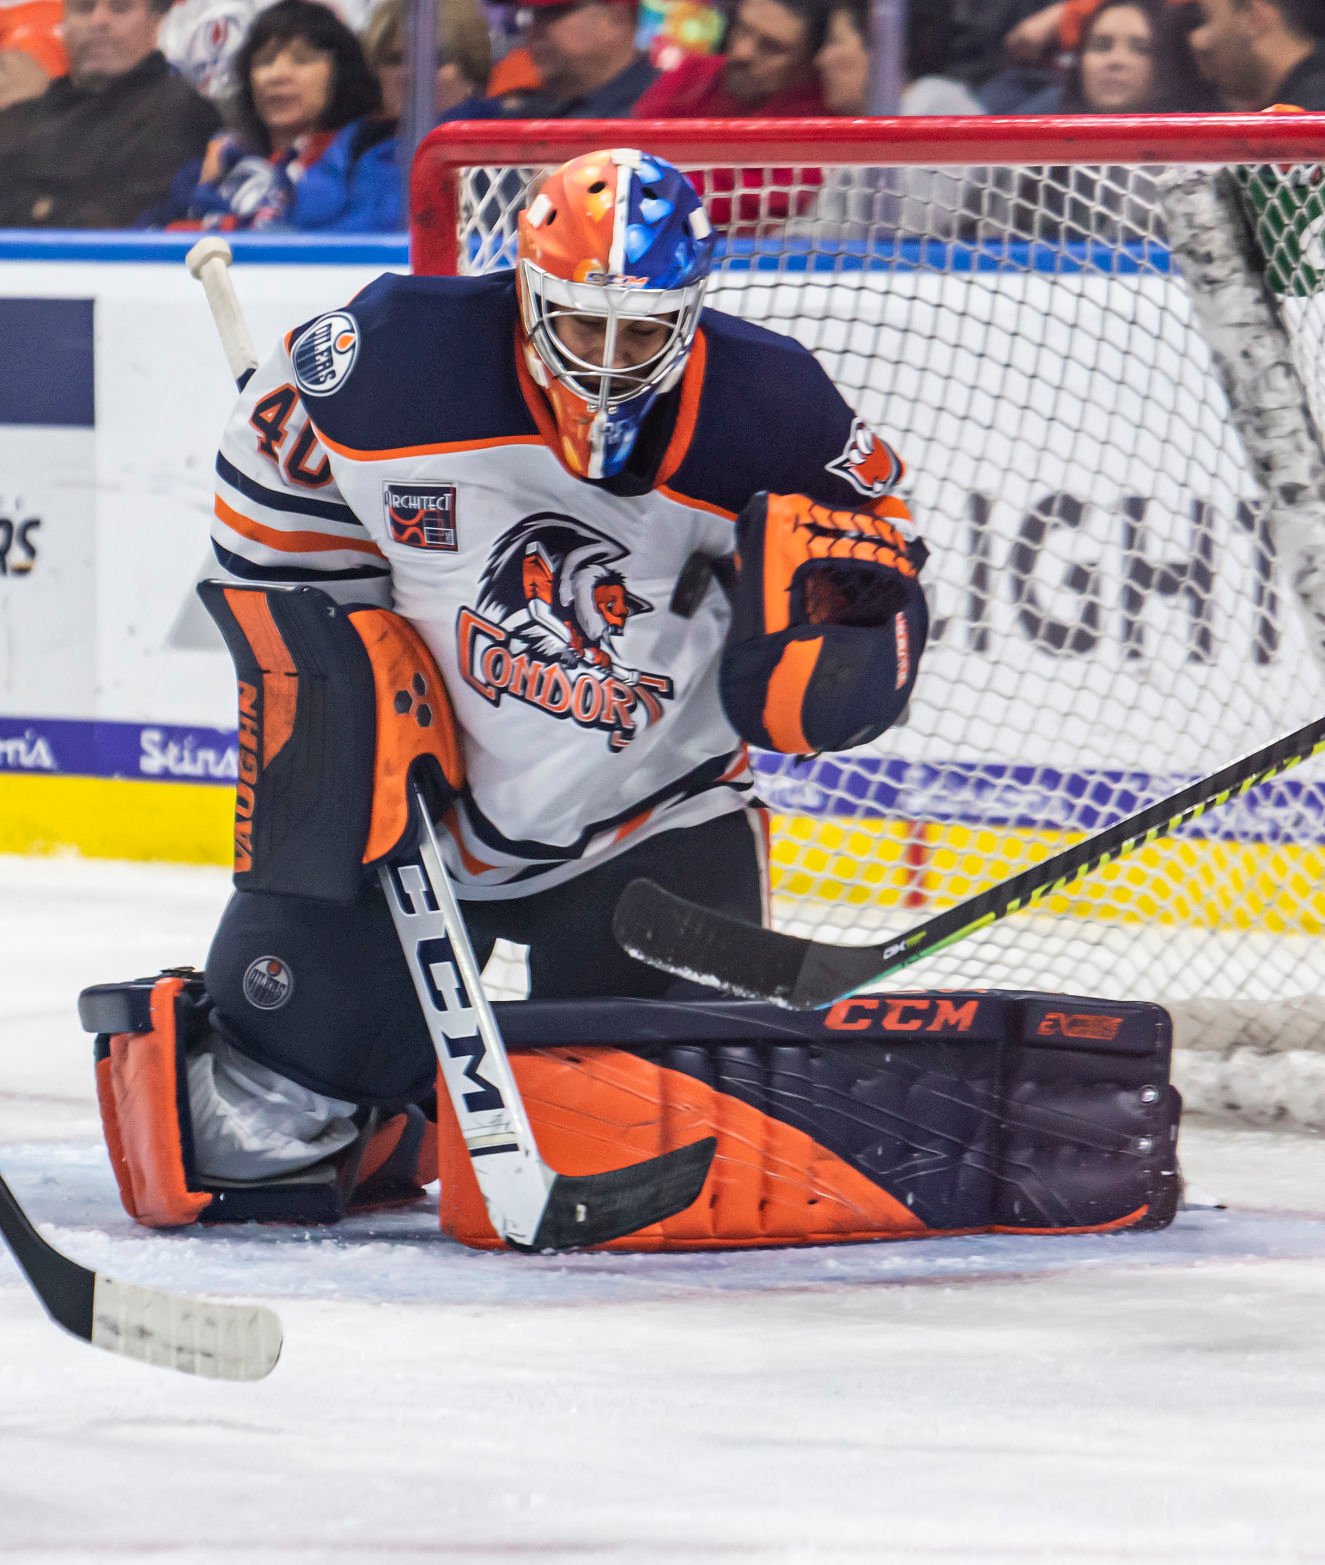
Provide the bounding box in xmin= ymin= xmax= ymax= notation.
xmin=413 ymin=116 xmax=1325 ymax=1125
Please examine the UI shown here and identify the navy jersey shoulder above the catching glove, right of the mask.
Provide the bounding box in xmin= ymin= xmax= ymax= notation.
xmin=668 ymin=310 xmax=882 ymax=512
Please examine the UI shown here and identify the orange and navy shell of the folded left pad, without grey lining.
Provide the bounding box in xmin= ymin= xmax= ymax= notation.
xmin=78 ymin=972 xmax=436 ymax=1229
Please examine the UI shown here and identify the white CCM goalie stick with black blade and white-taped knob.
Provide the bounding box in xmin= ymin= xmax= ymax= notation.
xmin=186 ymin=236 xmax=716 ymax=1250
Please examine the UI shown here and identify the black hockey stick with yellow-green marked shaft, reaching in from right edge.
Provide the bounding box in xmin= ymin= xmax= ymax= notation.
xmin=613 ymin=717 xmax=1325 ymax=1011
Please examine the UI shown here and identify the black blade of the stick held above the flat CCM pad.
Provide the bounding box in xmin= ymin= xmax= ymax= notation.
xmin=612 ymin=880 xmax=879 ymax=1011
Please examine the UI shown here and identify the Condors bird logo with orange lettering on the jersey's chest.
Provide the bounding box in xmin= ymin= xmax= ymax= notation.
xmin=455 ymin=510 xmax=673 ymax=750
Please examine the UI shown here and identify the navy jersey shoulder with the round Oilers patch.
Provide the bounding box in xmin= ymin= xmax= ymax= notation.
xmin=289 ymin=272 xmax=538 ymax=452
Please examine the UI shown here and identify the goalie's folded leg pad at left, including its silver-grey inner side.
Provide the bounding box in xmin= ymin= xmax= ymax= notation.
xmin=78 ymin=973 xmax=436 ymax=1229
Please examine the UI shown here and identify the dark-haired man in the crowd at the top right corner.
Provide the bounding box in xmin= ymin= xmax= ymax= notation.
xmin=1192 ymin=0 xmax=1325 ymax=111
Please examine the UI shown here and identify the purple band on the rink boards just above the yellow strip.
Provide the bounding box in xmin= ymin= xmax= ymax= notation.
xmin=0 ymin=717 xmax=1325 ymax=847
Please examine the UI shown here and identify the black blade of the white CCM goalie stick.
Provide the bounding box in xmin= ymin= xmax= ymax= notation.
xmin=519 ymin=1136 xmax=718 ymax=1250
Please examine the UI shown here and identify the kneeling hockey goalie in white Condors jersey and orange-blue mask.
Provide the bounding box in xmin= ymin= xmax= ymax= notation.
xmin=83 ymin=149 xmax=1178 ymax=1247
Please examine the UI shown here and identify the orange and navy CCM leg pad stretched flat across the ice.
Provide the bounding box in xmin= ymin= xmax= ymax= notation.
xmin=440 ymin=992 xmax=1181 ymax=1250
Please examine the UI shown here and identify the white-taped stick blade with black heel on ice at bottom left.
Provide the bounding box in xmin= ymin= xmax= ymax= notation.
xmin=0 ymin=1178 xmax=282 ymax=1380
